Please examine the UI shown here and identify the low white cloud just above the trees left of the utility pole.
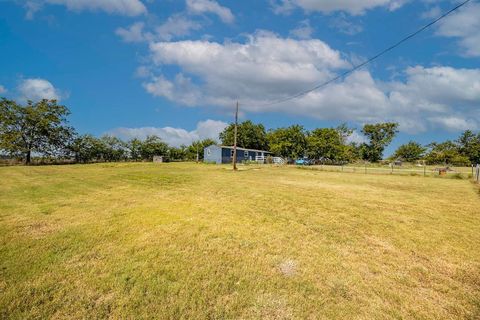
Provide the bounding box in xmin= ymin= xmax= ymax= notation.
xmin=109 ymin=119 xmax=228 ymax=147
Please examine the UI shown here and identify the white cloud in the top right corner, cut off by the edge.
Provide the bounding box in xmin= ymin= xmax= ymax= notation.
xmin=437 ymin=2 xmax=480 ymax=57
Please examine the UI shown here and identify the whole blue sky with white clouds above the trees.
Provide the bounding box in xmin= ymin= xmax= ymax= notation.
xmin=0 ymin=0 xmax=480 ymax=152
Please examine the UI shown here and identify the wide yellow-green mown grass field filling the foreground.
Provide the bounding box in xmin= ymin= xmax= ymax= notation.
xmin=0 ymin=163 xmax=480 ymax=319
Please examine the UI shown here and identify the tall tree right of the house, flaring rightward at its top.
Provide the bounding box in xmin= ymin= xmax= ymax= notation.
xmin=362 ymin=122 xmax=398 ymax=162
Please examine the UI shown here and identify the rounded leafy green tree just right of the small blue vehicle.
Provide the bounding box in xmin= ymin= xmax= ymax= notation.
xmin=307 ymin=128 xmax=347 ymax=161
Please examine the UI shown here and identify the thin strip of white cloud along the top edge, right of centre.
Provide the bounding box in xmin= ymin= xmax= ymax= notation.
xmin=270 ymin=0 xmax=408 ymax=15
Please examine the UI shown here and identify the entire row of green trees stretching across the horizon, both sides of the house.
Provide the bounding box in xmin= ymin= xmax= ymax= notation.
xmin=0 ymin=98 xmax=480 ymax=165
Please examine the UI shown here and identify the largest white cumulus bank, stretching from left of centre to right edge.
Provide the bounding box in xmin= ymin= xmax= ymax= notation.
xmin=144 ymin=32 xmax=480 ymax=132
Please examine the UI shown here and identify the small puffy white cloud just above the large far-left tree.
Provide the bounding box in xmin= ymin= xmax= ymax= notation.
xmin=17 ymin=78 xmax=62 ymax=101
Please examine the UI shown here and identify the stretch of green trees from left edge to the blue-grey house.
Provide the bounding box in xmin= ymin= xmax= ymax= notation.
xmin=0 ymin=98 xmax=216 ymax=164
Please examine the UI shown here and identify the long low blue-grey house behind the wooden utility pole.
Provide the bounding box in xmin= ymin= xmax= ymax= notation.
xmin=203 ymin=145 xmax=271 ymax=164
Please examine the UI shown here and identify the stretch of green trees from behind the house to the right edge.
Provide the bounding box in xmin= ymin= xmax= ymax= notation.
xmin=220 ymin=121 xmax=480 ymax=166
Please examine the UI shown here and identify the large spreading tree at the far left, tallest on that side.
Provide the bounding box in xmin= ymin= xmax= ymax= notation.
xmin=0 ymin=98 xmax=74 ymax=164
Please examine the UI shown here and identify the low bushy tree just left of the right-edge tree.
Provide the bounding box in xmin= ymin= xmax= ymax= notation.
xmin=425 ymin=141 xmax=470 ymax=166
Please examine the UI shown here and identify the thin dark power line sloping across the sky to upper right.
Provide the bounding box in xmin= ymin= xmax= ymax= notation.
xmin=255 ymin=0 xmax=471 ymax=107
